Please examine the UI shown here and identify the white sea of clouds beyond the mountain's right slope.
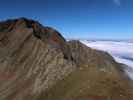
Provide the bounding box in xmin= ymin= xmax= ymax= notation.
xmin=81 ymin=40 xmax=133 ymax=80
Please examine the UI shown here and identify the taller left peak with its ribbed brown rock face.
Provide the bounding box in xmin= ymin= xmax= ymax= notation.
xmin=0 ymin=19 xmax=76 ymax=100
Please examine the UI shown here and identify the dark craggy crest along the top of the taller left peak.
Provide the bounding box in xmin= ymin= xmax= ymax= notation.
xmin=0 ymin=18 xmax=71 ymax=59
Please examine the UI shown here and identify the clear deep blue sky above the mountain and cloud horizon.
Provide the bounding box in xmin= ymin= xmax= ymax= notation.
xmin=0 ymin=0 xmax=133 ymax=39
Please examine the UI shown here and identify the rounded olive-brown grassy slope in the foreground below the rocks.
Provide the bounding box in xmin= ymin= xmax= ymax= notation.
xmin=37 ymin=64 xmax=133 ymax=100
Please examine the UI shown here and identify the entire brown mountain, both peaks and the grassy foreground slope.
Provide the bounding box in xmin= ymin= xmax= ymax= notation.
xmin=0 ymin=18 xmax=133 ymax=100
